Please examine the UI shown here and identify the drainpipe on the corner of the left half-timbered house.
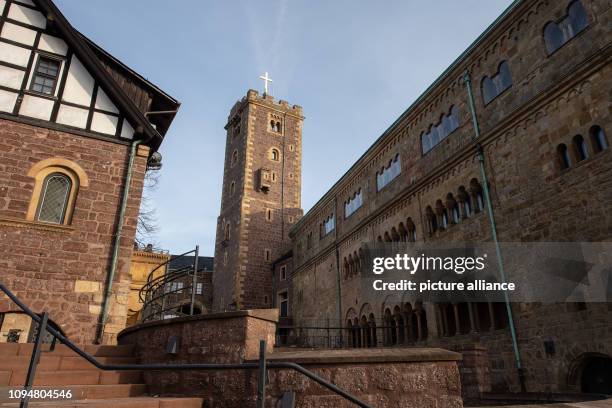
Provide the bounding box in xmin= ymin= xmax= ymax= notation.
xmin=96 ymin=140 xmax=143 ymax=344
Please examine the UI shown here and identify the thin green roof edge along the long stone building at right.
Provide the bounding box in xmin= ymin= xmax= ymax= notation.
xmin=289 ymin=0 xmax=524 ymax=234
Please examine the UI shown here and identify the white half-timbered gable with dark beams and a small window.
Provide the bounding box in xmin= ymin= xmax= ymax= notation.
xmin=0 ymin=0 xmax=143 ymax=140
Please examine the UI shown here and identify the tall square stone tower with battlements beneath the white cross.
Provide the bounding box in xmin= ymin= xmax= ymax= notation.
xmin=213 ymin=90 xmax=304 ymax=311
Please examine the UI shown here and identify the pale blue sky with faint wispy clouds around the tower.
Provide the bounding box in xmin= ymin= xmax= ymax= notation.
xmin=56 ymin=0 xmax=511 ymax=256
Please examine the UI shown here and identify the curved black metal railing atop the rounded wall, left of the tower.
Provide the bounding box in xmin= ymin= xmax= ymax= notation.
xmin=139 ymin=246 xmax=205 ymax=322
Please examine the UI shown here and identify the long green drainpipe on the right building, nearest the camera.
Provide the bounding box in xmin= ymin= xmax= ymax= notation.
xmin=463 ymin=71 xmax=526 ymax=392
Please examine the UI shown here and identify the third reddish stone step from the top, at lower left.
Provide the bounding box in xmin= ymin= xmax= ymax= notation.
xmin=0 ymin=370 xmax=142 ymax=387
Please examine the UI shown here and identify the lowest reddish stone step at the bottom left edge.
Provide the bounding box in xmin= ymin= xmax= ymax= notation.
xmin=0 ymin=397 xmax=202 ymax=408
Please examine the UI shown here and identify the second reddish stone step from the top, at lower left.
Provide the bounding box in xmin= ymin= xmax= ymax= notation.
xmin=0 ymin=353 xmax=139 ymax=371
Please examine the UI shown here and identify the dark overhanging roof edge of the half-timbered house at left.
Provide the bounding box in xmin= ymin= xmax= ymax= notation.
xmin=34 ymin=0 xmax=178 ymax=151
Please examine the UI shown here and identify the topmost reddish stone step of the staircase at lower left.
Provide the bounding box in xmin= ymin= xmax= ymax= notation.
xmin=0 ymin=343 xmax=134 ymax=357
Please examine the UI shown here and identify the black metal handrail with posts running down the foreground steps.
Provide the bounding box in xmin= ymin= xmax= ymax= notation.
xmin=0 ymin=283 xmax=371 ymax=408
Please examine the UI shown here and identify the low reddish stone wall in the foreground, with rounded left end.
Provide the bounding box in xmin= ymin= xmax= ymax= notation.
xmin=119 ymin=310 xmax=463 ymax=408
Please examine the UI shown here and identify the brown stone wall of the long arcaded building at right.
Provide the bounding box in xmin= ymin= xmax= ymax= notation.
xmin=284 ymin=0 xmax=612 ymax=392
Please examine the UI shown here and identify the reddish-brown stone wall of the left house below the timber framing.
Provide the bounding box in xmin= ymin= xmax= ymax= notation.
xmin=0 ymin=120 xmax=148 ymax=343
